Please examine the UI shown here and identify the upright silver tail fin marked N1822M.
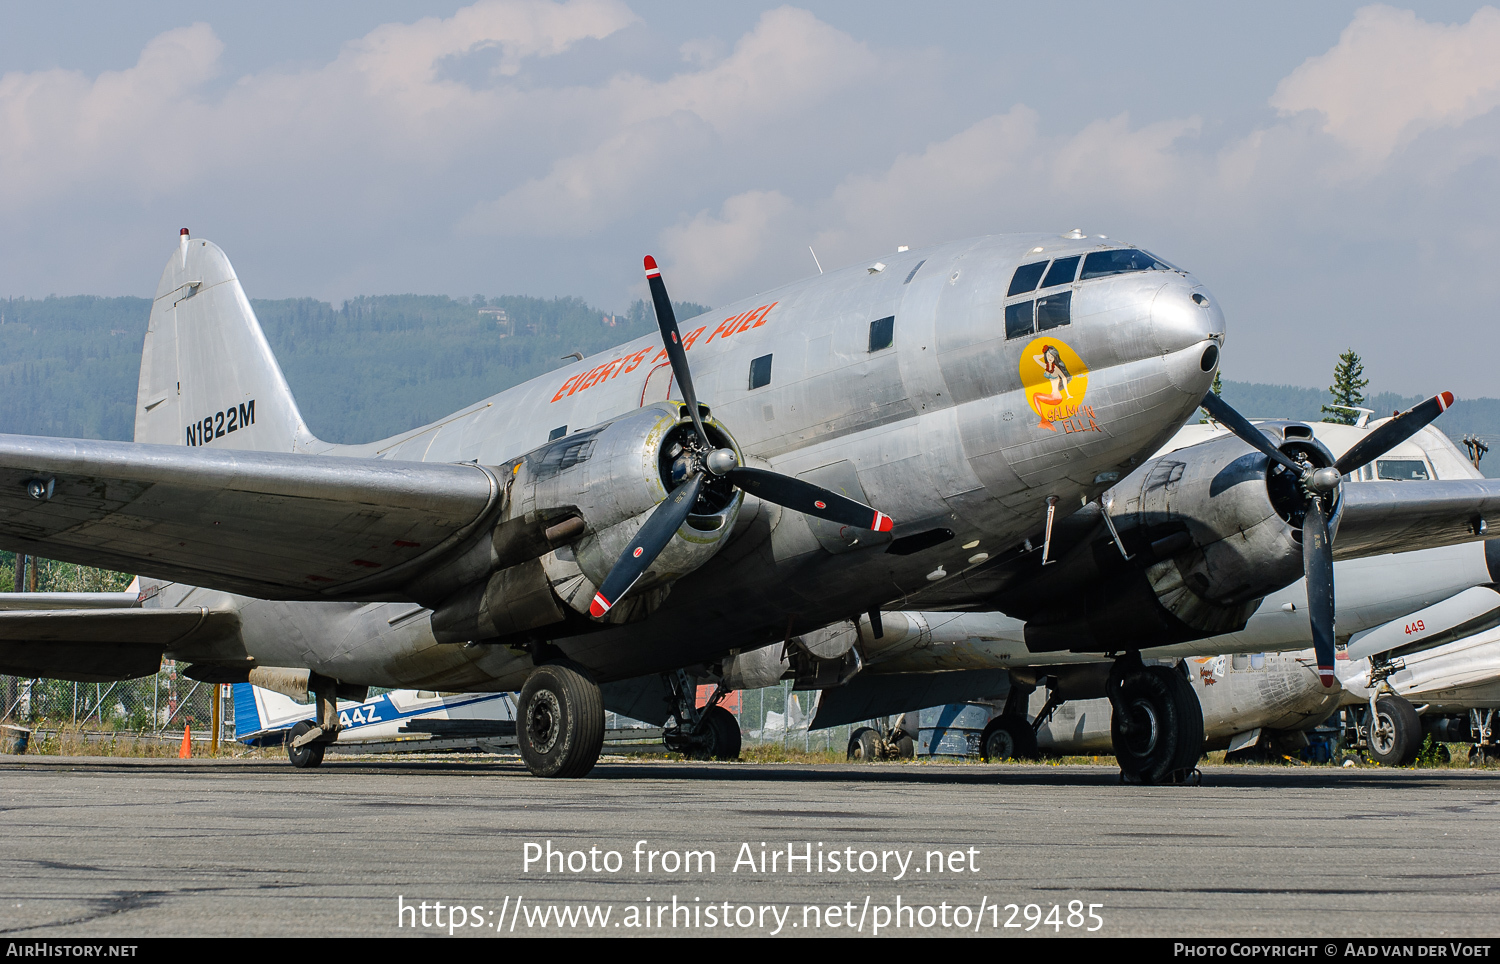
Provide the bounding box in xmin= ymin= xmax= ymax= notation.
xmin=135 ymin=228 xmax=317 ymax=451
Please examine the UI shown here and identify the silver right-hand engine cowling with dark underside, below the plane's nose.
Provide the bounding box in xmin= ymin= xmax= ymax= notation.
xmin=998 ymin=423 xmax=1343 ymax=652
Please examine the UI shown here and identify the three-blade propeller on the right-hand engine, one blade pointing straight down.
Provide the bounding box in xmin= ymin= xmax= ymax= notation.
xmin=1203 ymin=391 xmax=1454 ymax=687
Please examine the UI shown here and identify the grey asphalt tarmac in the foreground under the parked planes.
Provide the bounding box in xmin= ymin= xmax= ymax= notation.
xmin=0 ymin=757 xmax=1500 ymax=940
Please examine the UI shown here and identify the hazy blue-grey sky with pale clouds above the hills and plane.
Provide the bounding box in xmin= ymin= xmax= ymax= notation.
xmin=0 ymin=0 xmax=1500 ymax=396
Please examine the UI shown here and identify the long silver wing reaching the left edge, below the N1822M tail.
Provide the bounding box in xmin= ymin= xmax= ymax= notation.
xmin=0 ymin=435 xmax=503 ymax=600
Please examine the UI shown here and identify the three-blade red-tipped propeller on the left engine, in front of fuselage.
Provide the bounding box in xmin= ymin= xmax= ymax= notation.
xmin=588 ymin=255 xmax=894 ymax=618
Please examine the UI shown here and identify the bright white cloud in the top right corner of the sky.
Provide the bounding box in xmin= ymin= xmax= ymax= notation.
xmin=1271 ymin=6 xmax=1500 ymax=165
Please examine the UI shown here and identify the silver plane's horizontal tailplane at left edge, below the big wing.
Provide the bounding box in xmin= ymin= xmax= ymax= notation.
xmin=0 ymin=607 xmax=239 ymax=682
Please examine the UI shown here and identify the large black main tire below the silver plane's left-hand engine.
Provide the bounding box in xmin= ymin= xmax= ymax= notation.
xmin=516 ymin=663 xmax=605 ymax=778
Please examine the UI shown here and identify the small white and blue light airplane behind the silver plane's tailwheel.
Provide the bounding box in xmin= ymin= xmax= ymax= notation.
xmin=234 ymin=682 xmax=516 ymax=766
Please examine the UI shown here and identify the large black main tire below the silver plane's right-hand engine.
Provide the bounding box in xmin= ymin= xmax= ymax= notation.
xmin=1110 ymin=666 xmax=1203 ymax=784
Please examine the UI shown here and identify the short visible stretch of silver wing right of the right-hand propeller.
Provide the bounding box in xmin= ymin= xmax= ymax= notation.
xmin=1334 ymin=478 xmax=1500 ymax=559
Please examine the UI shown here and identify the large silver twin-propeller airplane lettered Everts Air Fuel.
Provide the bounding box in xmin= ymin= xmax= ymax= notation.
xmin=0 ymin=229 xmax=1500 ymax=783
